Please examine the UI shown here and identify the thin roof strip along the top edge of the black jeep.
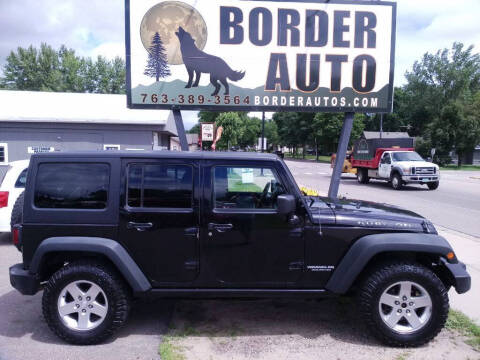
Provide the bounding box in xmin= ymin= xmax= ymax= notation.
xmin=32 ymin=150 xmax=280 ymax=161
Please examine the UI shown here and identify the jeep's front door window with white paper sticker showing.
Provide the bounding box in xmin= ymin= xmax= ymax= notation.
xmin=214 ymin=166 xmax=285 ymax=209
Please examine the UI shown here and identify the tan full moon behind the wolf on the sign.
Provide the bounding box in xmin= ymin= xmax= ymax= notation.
xmin=140 ymin=1 xmax=208 ymax=65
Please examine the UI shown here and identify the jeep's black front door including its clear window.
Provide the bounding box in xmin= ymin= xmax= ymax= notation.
xmin=202 ymin=161 xmax=304 ymax=288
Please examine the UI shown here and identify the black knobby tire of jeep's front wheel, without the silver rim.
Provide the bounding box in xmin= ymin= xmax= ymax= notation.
xmin=358 ymin=262 xmax=449 ymax=347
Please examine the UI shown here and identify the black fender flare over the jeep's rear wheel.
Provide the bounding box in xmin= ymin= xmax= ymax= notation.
xmin=29 ymin=236 xmax=152 ymax=293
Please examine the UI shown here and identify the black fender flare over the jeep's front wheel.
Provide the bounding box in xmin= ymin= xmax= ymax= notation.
xmin=325 ymin=233 xmax=453 ymax=294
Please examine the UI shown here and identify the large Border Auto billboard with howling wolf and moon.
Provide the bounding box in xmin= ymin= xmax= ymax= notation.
xmin=126 ymin=0 xmax=396 ymax=112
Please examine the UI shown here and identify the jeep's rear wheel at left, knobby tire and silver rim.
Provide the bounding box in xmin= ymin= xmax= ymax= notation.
xmin=42 ymin=260 xmax=130 ymax=345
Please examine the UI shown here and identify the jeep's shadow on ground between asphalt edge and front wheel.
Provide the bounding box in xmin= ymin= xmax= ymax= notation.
xmin=163 ymin=298 xmax=382 ymax=346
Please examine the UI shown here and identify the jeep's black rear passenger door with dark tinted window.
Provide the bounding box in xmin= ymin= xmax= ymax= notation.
xmin=119 ymin=159 xmax=199 ymax=286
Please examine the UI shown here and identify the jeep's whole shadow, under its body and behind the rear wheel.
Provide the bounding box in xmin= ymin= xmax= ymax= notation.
xmin=0 ymin=290 xmax=380 ymax=346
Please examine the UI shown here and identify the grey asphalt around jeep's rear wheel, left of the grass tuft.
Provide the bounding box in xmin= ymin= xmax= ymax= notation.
xmin=0 ymin=233 xmax=174 ymax=360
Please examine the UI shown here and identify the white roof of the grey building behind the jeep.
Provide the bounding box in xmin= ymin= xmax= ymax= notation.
xmin=0 ymin=90 xmax=172 ymax=126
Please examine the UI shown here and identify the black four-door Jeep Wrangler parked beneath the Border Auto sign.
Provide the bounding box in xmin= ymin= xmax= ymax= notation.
xmin=10 ymin=151 xmax=470 ymax=346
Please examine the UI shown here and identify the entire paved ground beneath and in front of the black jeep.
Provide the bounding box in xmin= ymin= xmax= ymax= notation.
xmin=0 ymin=234 xmax=478 ymax=360
